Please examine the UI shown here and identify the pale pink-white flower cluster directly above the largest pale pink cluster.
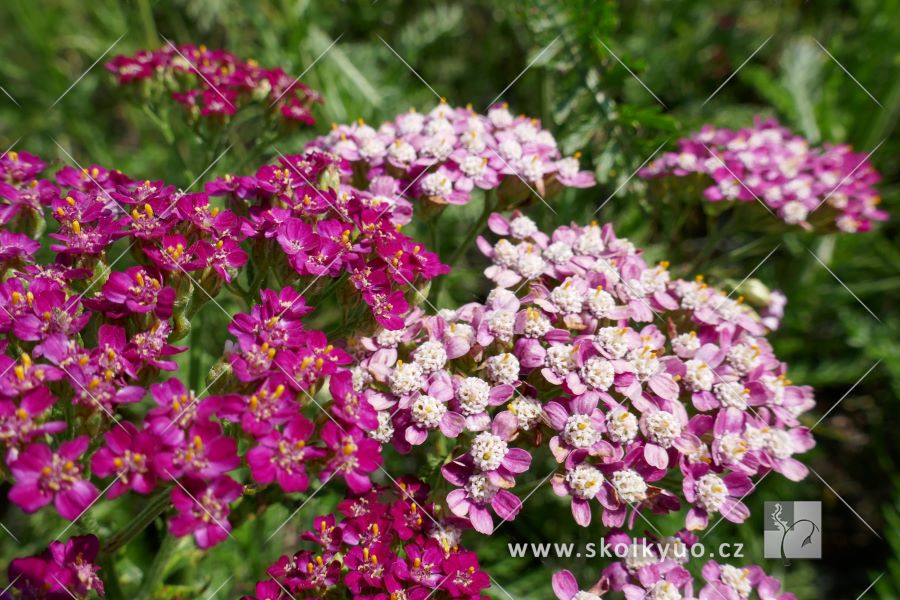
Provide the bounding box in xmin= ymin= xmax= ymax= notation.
xmin=310 ymin=102 xmax=595 ymax=204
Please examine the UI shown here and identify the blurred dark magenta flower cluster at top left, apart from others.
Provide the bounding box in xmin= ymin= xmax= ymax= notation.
xmin=106 ymin=44 xmax=322 ymax=125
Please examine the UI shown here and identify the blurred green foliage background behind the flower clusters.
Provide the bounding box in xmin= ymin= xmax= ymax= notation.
xmin=0 ymin=0 xmax=900 ymax=599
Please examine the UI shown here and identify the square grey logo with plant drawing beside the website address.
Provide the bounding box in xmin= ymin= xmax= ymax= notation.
xmin=763 ymin=502 xmax=822 ymax=562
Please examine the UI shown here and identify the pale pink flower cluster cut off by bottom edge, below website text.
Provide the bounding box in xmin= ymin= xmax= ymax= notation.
xmin=553 ymin=531 xmax=796 ymax=600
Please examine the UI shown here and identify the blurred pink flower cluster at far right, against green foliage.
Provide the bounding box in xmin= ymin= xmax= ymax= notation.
xmin=640 ymin=119 xmax=888 ymax=233
